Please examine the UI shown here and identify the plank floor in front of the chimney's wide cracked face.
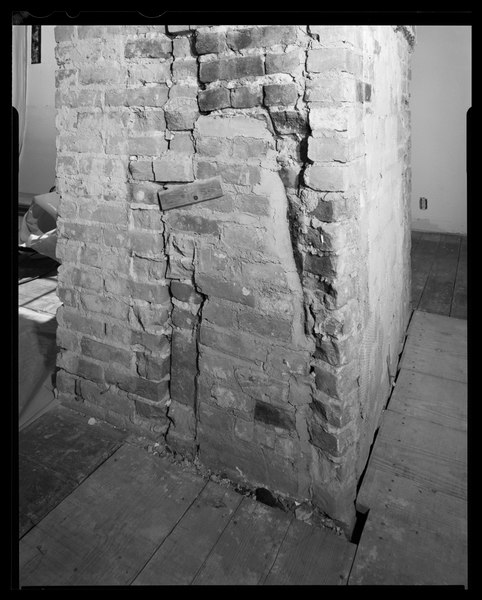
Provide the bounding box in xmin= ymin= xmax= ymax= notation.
xmin=19 ymin=407 xmax=355 ymax=587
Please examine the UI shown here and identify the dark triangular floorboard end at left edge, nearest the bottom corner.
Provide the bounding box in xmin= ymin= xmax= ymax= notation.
xmin=18 ymin=455 xmax=77 ymax=538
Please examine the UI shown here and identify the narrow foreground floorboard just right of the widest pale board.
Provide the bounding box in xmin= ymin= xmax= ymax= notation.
xmin=133 ymin=481 xmax=243 ymax=585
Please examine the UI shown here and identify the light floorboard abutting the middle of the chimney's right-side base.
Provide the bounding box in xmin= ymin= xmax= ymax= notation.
xmin=388 ymin=369 xmax=467 ymax=431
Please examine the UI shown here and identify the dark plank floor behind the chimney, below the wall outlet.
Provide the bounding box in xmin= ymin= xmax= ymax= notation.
xmin=411 ymin=231 xmax=467 ymax=319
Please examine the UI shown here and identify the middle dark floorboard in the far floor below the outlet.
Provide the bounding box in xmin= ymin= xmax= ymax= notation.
xmin=418 ymin=235 xmax=460 ymax=315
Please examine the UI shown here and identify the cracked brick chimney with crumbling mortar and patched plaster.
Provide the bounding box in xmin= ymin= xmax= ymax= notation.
xmin=56 ymin=25 xmax=409 ymax=528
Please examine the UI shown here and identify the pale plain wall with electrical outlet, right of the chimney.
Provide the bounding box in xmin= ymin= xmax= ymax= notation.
xmin=411 ymin=25 xmax=472 ymax=233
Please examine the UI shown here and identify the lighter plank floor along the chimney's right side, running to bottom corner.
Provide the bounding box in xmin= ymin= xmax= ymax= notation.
xmin=349 ymin=311 xmax=467 ymax=586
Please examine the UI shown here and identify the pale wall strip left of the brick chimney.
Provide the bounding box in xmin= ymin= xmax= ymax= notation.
xmin=18 ymin=25 xmax=57 ymax=195
